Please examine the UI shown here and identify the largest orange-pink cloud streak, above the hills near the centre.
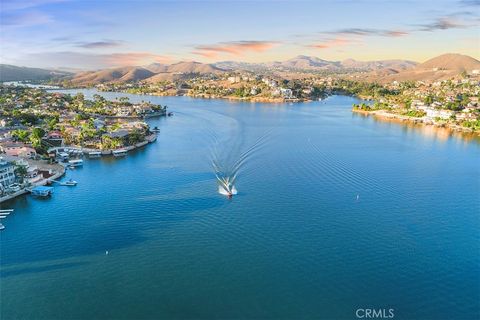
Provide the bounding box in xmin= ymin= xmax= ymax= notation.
xmin=192 ymin=41 xmax=278 ymax=58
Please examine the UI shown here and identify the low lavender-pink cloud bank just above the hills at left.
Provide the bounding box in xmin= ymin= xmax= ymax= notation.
xmin=14 ymin=51 xmax=172 ymax=69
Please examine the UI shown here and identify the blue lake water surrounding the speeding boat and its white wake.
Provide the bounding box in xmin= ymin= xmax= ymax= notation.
xmin=0 ymin=90 xmax=480 ymax=319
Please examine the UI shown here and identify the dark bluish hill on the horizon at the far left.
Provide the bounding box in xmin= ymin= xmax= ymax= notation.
xmin=0 ymin=64 xmax=71 ymax=81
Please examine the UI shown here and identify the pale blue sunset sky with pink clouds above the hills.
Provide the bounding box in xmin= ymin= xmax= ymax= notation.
xmin=0 ymin=0 xmax=480 ymax=69
